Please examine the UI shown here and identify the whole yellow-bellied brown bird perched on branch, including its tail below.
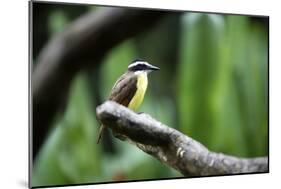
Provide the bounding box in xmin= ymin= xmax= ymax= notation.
xmin=97 ymin=59 xmax=160 ymax=144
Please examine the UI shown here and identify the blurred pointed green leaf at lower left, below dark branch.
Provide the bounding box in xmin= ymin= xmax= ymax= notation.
xmin=32 ymin=76 xmax=101 ymax=186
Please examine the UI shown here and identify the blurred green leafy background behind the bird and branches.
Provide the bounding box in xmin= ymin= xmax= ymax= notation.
xmin=32 ymin=3 xmax=268 ymax=186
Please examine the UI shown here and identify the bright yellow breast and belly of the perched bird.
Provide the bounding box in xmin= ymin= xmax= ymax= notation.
xmin=128 ymin=73 xmax=147 ymax=111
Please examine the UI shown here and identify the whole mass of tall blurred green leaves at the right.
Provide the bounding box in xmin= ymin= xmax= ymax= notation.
xmin=178 ymin=14 xmax=268 ymax=156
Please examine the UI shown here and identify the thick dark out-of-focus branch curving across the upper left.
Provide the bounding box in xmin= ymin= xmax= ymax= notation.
xmin=32 ymin=8 xmax=168 ymax=158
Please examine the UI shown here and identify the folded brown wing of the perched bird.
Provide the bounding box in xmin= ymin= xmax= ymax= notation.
xmin=109 ymin=72 xmax=137 ymax=107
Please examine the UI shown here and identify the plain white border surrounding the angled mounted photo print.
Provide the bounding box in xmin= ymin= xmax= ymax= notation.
xmin=0 ymin=0 xmax=281 ymax=189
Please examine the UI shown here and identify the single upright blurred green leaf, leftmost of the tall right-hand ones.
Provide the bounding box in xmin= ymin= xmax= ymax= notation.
xmin=177 ymin=14 xmax=223 ymax=148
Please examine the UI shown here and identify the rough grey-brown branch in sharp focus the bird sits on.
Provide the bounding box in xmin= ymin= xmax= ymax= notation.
xmin=97 ymin=101 xmax=268 ymax=176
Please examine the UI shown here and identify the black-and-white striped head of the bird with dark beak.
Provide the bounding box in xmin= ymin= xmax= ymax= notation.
xmin=128 ymin=59 xmax=160 ymax=74
